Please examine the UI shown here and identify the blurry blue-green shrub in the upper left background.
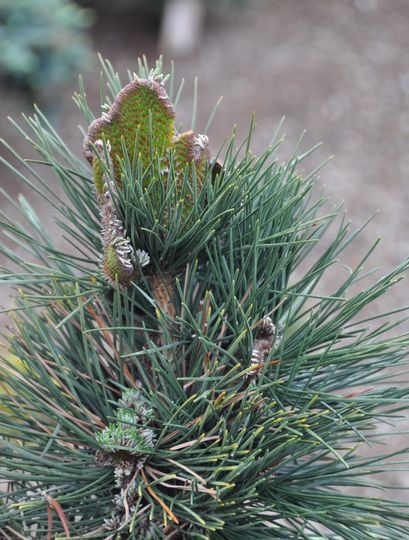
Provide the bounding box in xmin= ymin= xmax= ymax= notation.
xmin=0 ymin=0 xmax=93 ymax=92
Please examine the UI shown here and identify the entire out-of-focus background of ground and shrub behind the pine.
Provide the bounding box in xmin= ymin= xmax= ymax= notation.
xmin=0 ymin=0 xmax=409 ymax=496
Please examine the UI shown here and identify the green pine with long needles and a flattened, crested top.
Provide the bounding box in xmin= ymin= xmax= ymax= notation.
xmin=0 ymin=57 xmax=409 ymax=540
